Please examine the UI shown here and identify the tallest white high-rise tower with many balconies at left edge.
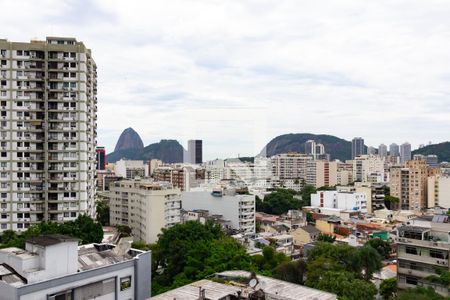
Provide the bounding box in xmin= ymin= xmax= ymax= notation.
xmin=0 ymin=37 xmax=97 ymax=231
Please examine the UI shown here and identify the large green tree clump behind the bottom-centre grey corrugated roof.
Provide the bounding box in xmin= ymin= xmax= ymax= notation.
xmin=152 ymin=221 xmax=253 ymax=295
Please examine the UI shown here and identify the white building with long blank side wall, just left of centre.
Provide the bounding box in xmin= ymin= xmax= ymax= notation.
xmin=182 ymin=187 xmax=256 ymax=234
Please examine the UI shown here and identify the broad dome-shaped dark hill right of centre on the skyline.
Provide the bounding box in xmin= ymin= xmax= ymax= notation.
xmin=261 ymin=133 xmax=352 ymax=161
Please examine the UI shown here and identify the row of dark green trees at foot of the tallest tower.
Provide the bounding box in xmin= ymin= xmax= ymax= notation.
xmin=0 ymin=215 xmax=103 ymax=248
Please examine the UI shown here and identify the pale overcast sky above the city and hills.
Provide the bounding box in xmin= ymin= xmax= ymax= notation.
xmin=0 ymin=0 xmax=450 ymax=159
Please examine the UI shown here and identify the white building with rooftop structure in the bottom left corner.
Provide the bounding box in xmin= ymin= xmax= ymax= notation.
xmin=0 ymin=235 xmax=151 ymax=300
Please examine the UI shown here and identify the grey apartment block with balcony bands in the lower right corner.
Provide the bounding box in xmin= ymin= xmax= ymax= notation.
xmin=396 ymin=219 xmax=450 ymax=297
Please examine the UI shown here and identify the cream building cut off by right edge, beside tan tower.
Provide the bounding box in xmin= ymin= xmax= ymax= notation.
xmin=428 ymin=174 xmax=450 ymax=209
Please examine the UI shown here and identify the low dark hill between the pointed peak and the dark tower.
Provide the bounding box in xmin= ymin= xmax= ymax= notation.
xmin=106 ymin=140 xmax=184 ymax=163
